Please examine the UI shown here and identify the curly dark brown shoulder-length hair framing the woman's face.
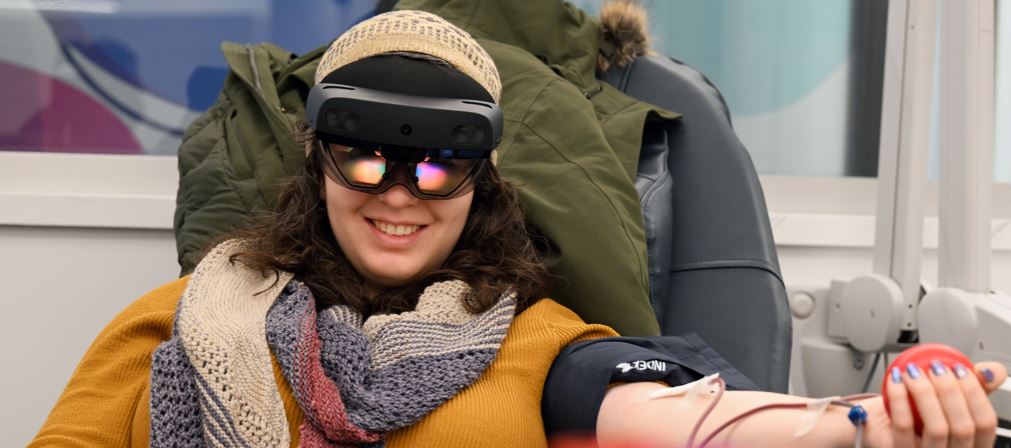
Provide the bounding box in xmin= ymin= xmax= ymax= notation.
xmin=226 ymin=135 xmax=548 ymax=316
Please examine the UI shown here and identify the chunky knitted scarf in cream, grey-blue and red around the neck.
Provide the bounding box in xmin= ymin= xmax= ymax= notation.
xmin=151 ymin=242 xmax=516 ymax=447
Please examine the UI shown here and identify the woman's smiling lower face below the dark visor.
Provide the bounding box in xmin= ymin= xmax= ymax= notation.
xmin=321 ymin=171 xmax=474 ymax=288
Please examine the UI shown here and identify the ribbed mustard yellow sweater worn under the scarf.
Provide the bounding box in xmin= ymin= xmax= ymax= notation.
xmin=28 ymin=277 xmax=617 ymax=448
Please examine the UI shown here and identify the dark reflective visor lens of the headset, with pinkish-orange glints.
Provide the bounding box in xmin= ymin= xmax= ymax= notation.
xmin=323 ymin=142 xmax=486 ymax=197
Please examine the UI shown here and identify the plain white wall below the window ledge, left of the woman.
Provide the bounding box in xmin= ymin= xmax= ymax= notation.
xmin=0 ymin=226 xmax=179 ymax=446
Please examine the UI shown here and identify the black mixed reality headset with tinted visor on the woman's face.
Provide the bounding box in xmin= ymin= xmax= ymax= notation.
xmin=305 ymin=83 xmax=502 ymax=199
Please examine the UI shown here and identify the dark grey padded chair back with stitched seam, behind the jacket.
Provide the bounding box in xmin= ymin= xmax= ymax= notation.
xmin=600 ymin=56 xmax=792 ymax=392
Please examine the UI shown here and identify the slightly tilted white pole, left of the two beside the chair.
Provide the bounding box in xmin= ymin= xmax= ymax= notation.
xmin=874 ymin=0 xmax=936 ymax=330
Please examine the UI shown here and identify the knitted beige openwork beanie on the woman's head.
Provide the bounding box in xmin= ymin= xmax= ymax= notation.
xmin=315 ymin=10 xmax=501 ymax=103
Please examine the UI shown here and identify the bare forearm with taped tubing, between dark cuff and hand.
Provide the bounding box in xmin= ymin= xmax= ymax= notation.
xmin=596 ymin=383 xmax=856 ymax=447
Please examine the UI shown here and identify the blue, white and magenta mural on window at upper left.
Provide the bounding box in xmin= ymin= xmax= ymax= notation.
xmin=0 ymin=0 xmax=377 ymax=155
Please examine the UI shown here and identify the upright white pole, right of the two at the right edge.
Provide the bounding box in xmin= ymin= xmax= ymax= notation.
xmin=938 ymin=0 xmax=995 ymax=294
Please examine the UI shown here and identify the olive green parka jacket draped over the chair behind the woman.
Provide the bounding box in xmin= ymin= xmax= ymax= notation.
xmin=175 ymin=0 xmax=676 ymax=336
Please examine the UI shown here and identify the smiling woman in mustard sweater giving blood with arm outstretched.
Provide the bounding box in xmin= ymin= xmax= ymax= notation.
xmin=32 ymin=7 xmax=1006 ymax=446
